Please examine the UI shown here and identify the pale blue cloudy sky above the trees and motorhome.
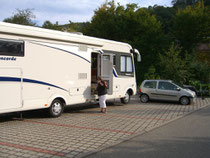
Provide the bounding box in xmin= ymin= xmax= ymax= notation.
xmin=0 ymin=0 xmax=172 ymax=25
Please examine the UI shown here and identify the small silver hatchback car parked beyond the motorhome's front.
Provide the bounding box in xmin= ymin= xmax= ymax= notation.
xmin=139 ymin=80 xmax=196 ymax=105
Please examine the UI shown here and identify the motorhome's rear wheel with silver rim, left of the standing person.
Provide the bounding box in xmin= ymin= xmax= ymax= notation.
xmin=49 ymin=99 xmax=64 ymax=117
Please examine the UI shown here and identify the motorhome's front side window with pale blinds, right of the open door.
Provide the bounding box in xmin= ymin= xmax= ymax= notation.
xmin=120 ymin=56 xmax=133 ymax=73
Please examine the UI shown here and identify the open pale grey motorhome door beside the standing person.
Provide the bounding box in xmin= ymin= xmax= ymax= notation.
xmin=101 ymin=53 xmax=113 ymax=95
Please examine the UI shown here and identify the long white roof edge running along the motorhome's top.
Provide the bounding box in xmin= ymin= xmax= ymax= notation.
xmin=0 ymin=22 xmax=131 ymax=48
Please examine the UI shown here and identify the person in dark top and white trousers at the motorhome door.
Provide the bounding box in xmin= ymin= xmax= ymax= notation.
xmin=96 ymin=77 xmax=108 ymax=113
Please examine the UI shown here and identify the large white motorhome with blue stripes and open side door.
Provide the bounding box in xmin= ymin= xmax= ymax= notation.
xmin=0 ymin=22 xmax=139 ymax=117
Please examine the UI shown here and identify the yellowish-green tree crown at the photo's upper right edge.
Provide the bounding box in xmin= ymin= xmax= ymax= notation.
xmin=172 ymin=2 xmax=210 ymax=52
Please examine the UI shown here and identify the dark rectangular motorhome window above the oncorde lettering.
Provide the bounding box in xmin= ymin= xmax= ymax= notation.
xmin=0 ymin=39 xmax=24 ymax=57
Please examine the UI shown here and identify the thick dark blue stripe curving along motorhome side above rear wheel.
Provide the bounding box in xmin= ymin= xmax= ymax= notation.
xmin=0 ymin=77 xmax=68 ymax=92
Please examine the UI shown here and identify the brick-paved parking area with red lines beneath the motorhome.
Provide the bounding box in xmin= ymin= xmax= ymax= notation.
xmin=0 ymin=96 xmax=210 ymax=158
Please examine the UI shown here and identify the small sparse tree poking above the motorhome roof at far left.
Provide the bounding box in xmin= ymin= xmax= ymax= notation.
xmin=4 ymin=9 xmax=36 ymax=26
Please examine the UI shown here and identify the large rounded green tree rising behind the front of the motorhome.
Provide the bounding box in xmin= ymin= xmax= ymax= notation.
xmin=84 ymin=1 xmax=168 ymax=82
